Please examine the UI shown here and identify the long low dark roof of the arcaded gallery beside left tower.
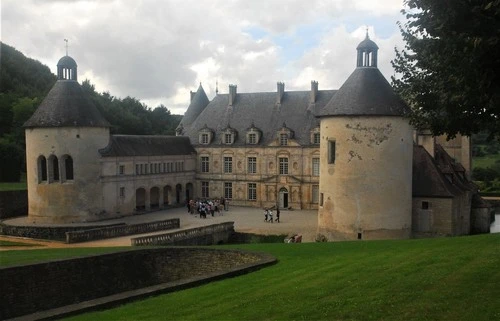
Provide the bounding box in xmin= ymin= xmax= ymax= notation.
xmin=99 ymin=135 xmax=196 ymax=157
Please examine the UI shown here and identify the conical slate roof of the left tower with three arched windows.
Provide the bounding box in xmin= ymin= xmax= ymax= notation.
xmin=24 ymin=79 xmax=110 ymax=128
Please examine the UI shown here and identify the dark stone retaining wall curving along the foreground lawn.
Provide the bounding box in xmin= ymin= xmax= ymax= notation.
xmin=0 ymin=247 xmax=275 ymax=318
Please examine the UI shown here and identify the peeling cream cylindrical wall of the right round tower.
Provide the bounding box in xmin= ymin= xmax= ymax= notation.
xmin=318 ymin=116 xmax=413 ymax=240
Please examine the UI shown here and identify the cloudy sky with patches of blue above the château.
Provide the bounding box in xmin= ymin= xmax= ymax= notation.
xmin=1 ymin=0 xmax=404 ymax=114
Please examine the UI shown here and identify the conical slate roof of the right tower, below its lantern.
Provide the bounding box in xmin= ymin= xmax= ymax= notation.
xmin=318 ymin=67 xmax=409 ymax=117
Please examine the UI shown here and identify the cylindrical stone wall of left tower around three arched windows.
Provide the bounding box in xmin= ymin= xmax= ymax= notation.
xmin=26 ymin=127 xmax=109 ymax=223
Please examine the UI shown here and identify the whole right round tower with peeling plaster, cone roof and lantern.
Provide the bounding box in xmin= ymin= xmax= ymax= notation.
xmin=318 ymin=34 xmax=413 ymax=240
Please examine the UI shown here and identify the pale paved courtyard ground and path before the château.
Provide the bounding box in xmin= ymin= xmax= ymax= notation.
xmin=0 ymin=206 xmax=318 ymax=250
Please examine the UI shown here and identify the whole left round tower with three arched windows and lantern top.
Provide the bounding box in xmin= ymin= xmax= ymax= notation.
xmin=24 ymin=56 xmax=110 ymax=223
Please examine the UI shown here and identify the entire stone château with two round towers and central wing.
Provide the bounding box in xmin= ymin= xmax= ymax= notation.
xmin=25 ymin=36 xmax=489 ymax=240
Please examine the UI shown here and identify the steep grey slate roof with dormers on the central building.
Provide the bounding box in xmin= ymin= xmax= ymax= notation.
xmin=183 ymin=90 xmax=336 ymax=146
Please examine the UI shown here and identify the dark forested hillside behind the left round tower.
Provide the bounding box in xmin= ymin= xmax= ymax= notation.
xmin=0 ymin=42 xmax=182 ymax=182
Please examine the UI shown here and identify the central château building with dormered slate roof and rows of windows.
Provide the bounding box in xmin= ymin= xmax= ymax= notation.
xmin=177 ymin=81 xmax=335 ymax=209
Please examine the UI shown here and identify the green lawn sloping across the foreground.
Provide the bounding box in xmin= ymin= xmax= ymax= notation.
xmin=1 ymin=234 xmax=500 ymax=321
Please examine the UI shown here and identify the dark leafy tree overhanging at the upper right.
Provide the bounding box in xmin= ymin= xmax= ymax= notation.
xmin=392 ymin=0 xmax=500 ymax=138
